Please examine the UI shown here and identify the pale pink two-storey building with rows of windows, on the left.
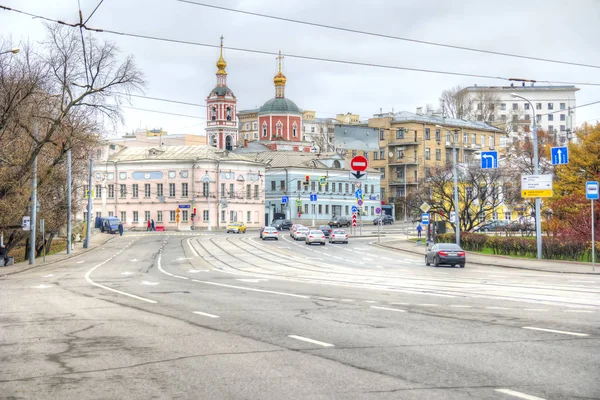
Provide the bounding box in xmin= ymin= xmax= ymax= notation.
xmin=78 ymin=146 xmax=265 ymax=230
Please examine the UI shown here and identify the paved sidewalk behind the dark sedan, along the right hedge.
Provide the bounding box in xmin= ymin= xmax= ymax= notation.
xmin=373 ymin=239 xmax=600 ymax=276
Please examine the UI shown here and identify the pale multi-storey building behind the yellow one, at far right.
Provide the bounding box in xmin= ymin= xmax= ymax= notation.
xmin=462 ymin=83 xmax=579 ymax=142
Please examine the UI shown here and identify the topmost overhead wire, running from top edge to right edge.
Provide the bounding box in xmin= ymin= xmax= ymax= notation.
xmin=175 ymin=0 xmax=600 ymax=68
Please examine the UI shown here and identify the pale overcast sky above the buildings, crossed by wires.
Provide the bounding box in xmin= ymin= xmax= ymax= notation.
xmin=0 ymin=0 xmax=600 ymax=138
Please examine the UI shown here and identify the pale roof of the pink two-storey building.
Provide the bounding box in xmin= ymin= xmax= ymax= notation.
xmin=108 ymin=145 xmax=262 ymax=162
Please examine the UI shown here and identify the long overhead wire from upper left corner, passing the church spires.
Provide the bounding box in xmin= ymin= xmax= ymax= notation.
xmin=0 ymin=5 xmax=600 ymax=86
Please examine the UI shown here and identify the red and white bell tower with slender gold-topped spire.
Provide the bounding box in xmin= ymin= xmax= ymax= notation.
xmin=206 ymin=36 xmax=239 ymax=150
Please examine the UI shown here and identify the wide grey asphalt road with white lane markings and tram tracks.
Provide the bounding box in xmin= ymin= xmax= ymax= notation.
xmin=0 ymin=228 xmax=600 ymax=400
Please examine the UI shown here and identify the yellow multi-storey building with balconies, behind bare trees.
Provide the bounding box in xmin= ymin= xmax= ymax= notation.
xmin=363 ymin=111 xmax=505 ymax=202
